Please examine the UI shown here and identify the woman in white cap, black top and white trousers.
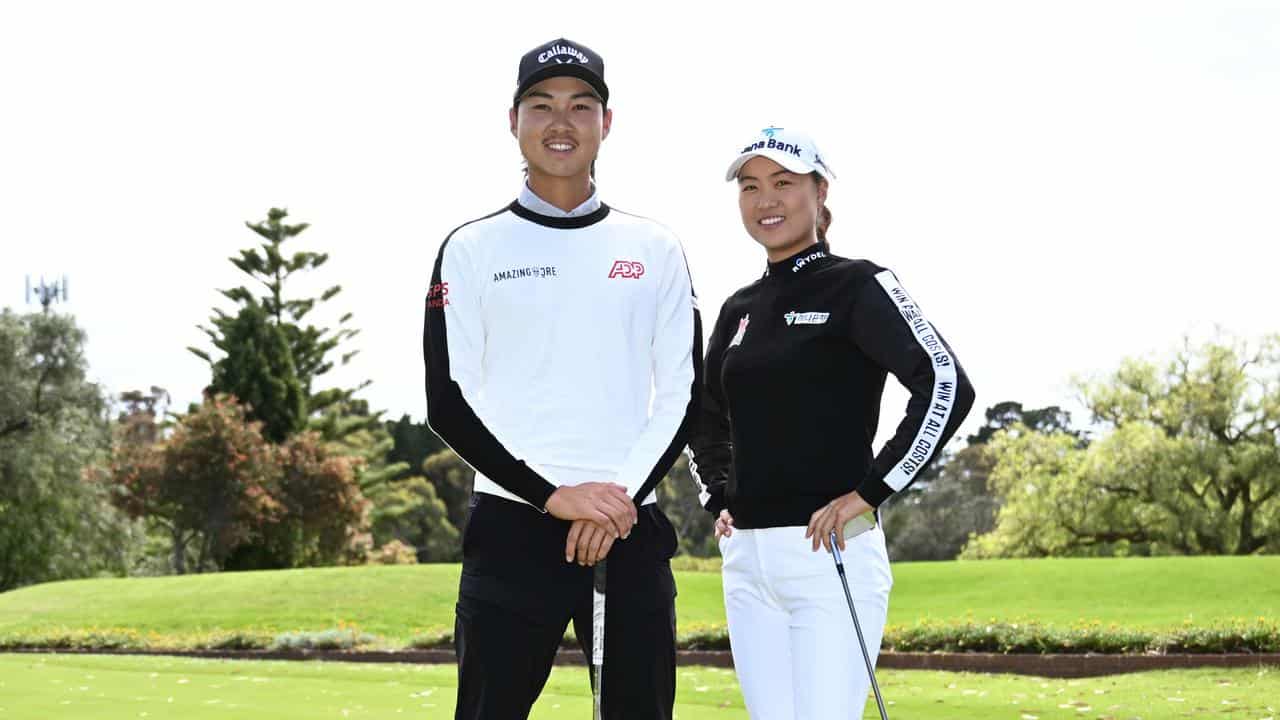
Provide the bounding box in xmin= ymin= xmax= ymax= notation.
xmin=690 ymin=127 xmax=973 ymax=720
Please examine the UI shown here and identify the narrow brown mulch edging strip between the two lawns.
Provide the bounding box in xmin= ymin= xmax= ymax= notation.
xmin=10 ymin=640 xmax=1280 ymax=678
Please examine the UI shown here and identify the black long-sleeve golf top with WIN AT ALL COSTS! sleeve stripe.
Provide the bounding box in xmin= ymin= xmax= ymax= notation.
xmin=690 ymin=243 xmax=974 ymax=528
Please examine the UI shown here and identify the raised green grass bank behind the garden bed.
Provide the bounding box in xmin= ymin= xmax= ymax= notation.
xmin=0 ymin=557 xmax=1280 ymax=644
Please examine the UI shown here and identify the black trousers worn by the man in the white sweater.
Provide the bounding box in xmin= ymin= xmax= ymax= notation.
xmin=454 ymin=493 xmax=676 ymax=720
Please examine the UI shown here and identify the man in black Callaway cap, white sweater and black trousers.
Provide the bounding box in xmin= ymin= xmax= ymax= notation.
xmin=422 ymin=38 xmax=701 ymax=720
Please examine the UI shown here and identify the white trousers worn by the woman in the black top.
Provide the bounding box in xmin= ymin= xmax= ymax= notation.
xmin=719 ymin=527 xmax=893 ymax=720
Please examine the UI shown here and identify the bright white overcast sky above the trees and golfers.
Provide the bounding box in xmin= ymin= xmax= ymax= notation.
xmin=0 ymin=0 xmax=1280 ymax=445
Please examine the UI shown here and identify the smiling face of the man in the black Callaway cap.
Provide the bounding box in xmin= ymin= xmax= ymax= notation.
xmin=511 ymin=77 xmax=613 ymax=178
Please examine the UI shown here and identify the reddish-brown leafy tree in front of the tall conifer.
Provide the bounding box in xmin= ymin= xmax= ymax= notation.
xmin=108 ymin=396 xmax=370 ymax=574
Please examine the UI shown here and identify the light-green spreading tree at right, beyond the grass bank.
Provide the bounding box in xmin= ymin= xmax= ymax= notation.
xmin=965 ymin=337 xmax=1280 ymax=557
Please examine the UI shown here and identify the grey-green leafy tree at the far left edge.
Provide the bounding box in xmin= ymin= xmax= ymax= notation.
xmin=0 ymin=309 xmax=141 ymax=592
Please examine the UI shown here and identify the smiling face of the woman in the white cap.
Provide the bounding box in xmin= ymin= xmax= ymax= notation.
xmin=737 ymin=156 xmax=827 ymax=260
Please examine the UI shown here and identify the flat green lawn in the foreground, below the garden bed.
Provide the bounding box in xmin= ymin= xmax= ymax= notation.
xmin=0 ymin=653 xmax=1280 ymax=720
